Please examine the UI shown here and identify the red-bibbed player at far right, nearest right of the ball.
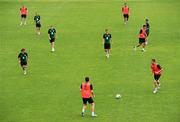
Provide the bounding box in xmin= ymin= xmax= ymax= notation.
xmin=151 ymin=59 xmax=163 ymax=93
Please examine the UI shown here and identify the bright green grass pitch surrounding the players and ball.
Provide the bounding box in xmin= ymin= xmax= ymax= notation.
xmin=0 ymin=0 xmax=180 ymax=122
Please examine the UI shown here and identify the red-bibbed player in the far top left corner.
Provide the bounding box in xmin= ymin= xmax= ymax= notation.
xmin=20 ymin=5 xmax=28 ymax=25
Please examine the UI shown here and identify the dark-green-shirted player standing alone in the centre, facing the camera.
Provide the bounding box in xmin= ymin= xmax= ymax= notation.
xmin=103 ymin=29 xmax=112 ymax=58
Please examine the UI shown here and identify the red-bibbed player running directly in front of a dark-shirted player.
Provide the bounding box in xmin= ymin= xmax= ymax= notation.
xmin=134 ymin=25 xmax=147 ymax=52
